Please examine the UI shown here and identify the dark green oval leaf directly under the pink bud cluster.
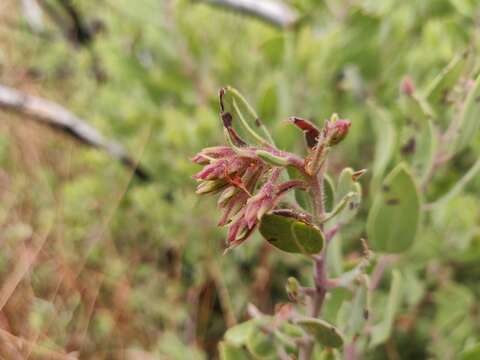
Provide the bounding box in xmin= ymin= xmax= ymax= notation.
xmin=260 ymin=214 xmax=324 ymax=254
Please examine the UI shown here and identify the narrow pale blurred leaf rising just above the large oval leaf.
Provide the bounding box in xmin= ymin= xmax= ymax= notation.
xmin=370 ymin=103 xmax=396 ymax=191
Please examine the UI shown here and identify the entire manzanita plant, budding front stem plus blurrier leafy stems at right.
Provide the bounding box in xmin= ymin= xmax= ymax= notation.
xmin=193 ymin=67 xmax=480 ymax=360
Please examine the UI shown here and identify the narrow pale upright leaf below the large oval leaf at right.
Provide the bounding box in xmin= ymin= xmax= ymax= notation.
xmin=370 ymin=270 xmax=402 ymax=347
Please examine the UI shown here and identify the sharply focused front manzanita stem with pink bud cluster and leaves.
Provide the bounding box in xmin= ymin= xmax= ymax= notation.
xmin=193 ymin=87 xmax=376 ymax=359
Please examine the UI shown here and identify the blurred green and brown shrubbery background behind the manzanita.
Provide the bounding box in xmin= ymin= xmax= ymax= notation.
xmin=0 ymin=0 xmax=480 ymax=359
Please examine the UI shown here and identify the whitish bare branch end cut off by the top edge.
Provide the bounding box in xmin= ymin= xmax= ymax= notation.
xmin=196 ymin=0 xmax=299 ymax=29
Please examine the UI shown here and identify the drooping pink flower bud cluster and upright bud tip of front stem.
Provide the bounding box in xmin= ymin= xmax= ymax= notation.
xmin=192 ymin=89 xmax=344 ymax=248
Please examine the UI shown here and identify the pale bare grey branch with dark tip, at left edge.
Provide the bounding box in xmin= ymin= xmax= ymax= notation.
xmin=0 ymin=85 xmax=150 ymax=181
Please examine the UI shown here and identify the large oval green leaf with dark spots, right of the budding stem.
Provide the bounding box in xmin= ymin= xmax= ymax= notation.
xmin=367 ymin=164 xmax=420 ymax=253
